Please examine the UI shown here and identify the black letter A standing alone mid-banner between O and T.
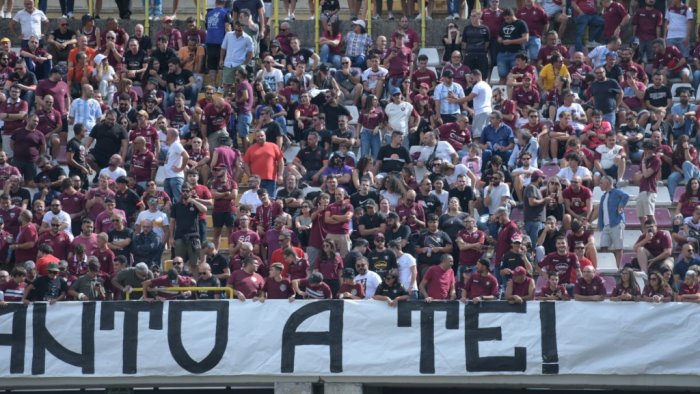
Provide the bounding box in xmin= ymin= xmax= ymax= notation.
xmin=281 ymin=300 xmax=344 ymax=373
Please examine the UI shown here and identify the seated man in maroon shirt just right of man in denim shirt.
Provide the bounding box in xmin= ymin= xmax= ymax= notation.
xmin=634 ymin=219 xmax=673 ymax=272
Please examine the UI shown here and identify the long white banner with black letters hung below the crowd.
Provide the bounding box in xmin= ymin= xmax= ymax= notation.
xmin=0 ymin=300 xmax=700 ymax=380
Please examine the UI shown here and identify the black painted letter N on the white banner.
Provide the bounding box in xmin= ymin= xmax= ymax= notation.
xmin=32 ymin=302 xmax=96 ymax=375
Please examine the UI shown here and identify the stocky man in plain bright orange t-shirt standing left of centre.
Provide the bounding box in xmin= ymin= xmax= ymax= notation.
xmin=243 ymin=130 xmax=284 ymax=198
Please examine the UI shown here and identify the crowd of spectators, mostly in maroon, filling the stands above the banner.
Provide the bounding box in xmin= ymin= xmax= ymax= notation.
xmin=0 ymin=0 xmax=700 ymax=306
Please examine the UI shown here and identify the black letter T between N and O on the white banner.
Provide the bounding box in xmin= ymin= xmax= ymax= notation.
xmin=100 ymin=301 xmax=163 ymax=375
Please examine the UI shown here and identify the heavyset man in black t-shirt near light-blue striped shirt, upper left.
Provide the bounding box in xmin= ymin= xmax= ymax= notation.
xmin=85 ymin=110 xmax=129 ymax=177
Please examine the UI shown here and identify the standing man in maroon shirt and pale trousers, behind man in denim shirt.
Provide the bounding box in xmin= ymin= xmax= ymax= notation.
xmin=637 ymin=141 xmax=661 ymax=223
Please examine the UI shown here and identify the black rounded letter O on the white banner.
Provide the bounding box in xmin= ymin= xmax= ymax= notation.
xmin=168 ymin=301 xmax=229 ymax=373
